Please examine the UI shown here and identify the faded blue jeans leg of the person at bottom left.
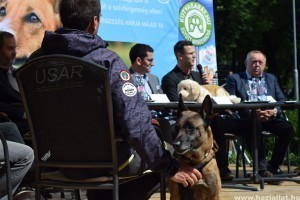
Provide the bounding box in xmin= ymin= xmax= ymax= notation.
xmin=0 ymin=141 xmax=34 ymax=200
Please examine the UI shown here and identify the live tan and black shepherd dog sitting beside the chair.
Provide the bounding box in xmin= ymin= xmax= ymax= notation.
xmin=168 ymin=95 xmax=221 ymax=200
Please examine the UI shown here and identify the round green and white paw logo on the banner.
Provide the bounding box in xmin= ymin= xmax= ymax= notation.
xmin=179 ymin=2 xmax=212 ymax=46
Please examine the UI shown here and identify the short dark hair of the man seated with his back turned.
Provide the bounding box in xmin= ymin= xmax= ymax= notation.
xmin=59 ymin=0 xmax=101 ymax=31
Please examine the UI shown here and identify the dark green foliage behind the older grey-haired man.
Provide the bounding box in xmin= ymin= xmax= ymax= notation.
xmin=214 ymin=0 xmax=300 ymax=164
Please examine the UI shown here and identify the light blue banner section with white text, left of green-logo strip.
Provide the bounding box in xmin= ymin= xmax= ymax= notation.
xmin=98 ymin=0 xmax=179 ymax=79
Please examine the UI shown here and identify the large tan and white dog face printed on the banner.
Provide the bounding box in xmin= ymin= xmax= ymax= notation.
xmin=0 ymin=0 xmax=61 ymax=64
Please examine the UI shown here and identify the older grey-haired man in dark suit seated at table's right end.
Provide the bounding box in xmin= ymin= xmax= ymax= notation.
xmin=212 ymin=50 xmax=295 ymax=181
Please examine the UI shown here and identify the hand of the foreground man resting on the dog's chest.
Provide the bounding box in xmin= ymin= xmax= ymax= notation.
xmin=171 ymin=163 xmax=202 ymax=187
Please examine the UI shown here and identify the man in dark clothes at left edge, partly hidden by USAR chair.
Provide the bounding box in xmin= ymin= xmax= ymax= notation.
xmin=0 ymin=31 xmax=29 ymax=135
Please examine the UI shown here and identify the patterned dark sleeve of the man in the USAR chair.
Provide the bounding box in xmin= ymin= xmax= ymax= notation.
xmin=109 ymin=54 xmax=178 ymax=176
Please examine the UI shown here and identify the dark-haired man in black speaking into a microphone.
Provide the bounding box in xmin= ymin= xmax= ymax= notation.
xmin=162 ymin=40 xmax=210 ymax=101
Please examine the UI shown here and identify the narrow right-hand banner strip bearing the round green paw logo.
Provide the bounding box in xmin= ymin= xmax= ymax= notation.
xmin=178 ymin=0 xmax=217 ymax=84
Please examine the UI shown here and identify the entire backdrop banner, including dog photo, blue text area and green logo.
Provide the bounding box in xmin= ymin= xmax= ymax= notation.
xmin=0 ymin=0 xmax=216 ymax=82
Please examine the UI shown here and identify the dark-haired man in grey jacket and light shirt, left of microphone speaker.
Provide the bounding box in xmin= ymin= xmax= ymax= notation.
xmin=129 ymin=44 xmax=162 ymax=99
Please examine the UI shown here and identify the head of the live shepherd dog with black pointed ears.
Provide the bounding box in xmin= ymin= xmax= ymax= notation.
xmin=173 ymin=95 xmax=217 ymax=165
